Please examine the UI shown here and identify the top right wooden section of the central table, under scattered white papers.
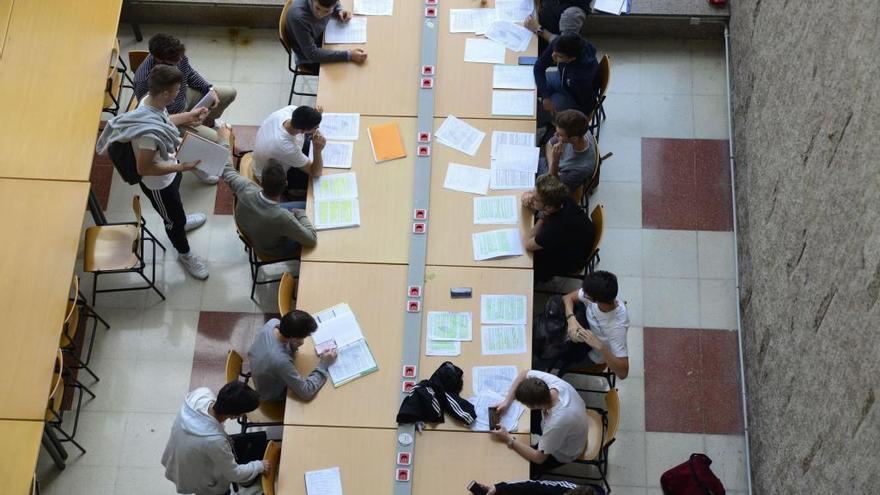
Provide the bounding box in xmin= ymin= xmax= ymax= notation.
xmin=434 ymin=0 xmax=538 ymax=122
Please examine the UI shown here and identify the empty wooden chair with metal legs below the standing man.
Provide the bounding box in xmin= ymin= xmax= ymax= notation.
xmin=83 ymin=196 xmax=165 ymax=304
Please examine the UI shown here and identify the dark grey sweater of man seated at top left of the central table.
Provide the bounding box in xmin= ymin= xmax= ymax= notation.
xmin=284 ymin=0 xmax=349 ymax=64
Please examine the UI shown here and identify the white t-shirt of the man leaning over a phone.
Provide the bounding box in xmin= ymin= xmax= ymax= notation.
xmin=526 ymin=370 xmax=588 ymax=462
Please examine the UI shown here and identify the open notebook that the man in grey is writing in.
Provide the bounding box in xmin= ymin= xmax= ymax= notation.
xmin=312 ymin=303 xmax=379 ymax=387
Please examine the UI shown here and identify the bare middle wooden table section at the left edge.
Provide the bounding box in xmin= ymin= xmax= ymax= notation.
xmin=0 ymin=179 xmax=89 ymax=421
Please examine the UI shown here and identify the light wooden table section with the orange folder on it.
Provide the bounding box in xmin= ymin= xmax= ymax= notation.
xmin=302 ymin=115 xmax=416 ymax=264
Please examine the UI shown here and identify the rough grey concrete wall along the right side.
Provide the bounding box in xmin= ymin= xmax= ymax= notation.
xmin=730 ymin=0 xmax=880 ymax=494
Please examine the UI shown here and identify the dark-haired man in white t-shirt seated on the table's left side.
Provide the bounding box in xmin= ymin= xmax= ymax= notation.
xmin=254 ymin=105 xmax=327 ymax=191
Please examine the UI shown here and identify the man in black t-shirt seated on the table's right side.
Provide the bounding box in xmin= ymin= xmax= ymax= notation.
xmin=522 ymin=175 xmax=595 ymax=282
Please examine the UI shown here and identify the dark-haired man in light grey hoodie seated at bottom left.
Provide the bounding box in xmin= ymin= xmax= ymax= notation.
xmin=162 ymin=381 xmax=271 ymax=495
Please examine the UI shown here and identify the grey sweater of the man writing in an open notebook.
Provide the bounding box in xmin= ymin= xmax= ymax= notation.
xmin=248 ymin=318 xmax=328 ymax=402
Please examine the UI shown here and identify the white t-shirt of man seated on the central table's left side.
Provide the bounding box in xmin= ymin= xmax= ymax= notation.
xmin=254 ymin=105 xmax=309 ymax=179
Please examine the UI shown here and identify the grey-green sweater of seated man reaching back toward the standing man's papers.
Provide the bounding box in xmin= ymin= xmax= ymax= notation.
xmin=223 ymin=163 xmax=318 ymax=256
